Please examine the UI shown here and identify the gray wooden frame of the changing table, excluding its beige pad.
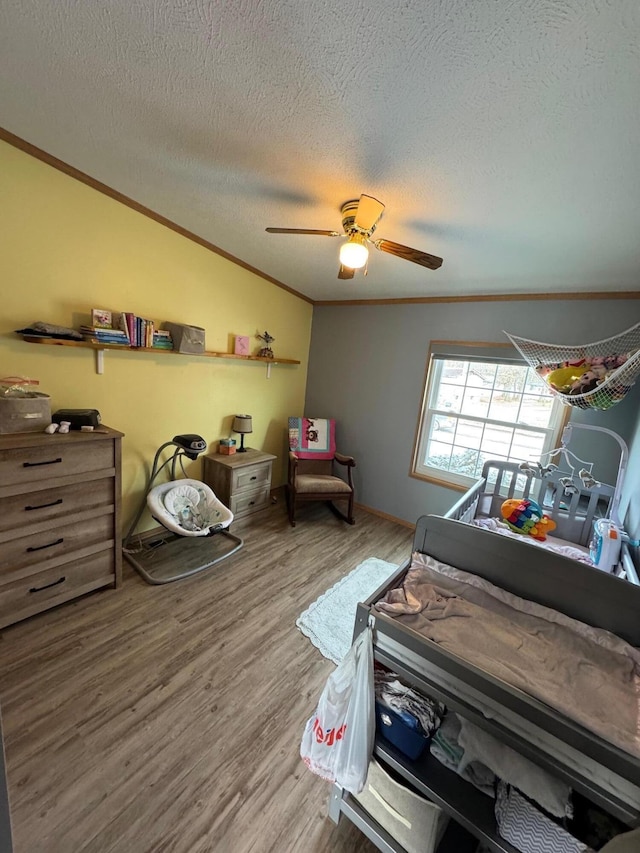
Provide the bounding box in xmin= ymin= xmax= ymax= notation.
xmin=329 ymin=516 xmax=640 ymax=853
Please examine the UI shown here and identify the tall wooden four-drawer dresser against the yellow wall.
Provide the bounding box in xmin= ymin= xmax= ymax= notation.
xmin=0 ymin=427 xmax=122 ymax=627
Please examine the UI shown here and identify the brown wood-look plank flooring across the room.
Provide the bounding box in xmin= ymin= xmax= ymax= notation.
xmin=0 ymin=502 xmax=412 ymax=853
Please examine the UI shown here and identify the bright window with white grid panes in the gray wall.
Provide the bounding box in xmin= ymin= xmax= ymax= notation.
xmin=413 ymin=354 xmax=564 ymax=487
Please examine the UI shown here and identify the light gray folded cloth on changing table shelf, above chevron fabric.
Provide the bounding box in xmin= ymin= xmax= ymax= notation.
xmin=459 ymin=718 xmax=571 ymax=818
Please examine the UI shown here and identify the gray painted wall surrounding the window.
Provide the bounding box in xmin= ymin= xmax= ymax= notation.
xmin=304 ymin=299 xmax=640 ymax=524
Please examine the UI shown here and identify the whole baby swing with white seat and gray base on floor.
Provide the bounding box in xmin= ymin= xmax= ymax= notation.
xmin=123 ymin=434 xmax=243 ymax=584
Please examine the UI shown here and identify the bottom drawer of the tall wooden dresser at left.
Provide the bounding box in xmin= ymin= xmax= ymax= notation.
xmin=0 ymin=549 xmax=115 ymax=627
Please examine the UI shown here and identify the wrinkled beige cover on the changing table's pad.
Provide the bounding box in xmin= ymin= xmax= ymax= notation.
xmin=376 ymin=554 xmax=640 ymax=757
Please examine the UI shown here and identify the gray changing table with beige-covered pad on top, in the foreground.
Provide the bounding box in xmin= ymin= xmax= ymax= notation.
xmin=330 ymin=516 xmax=640 ymax=853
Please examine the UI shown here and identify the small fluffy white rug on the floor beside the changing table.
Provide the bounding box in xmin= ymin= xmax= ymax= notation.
xmin=296 ymin=557 xmax=398 ymax=663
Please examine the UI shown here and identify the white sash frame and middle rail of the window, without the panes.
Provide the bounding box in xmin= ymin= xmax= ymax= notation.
xmin=411 ymin=342 xmax=568 ymax=489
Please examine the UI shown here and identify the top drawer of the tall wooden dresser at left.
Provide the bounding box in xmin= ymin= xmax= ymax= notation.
xmin=0 ymin=436 xmax=115 ymax=491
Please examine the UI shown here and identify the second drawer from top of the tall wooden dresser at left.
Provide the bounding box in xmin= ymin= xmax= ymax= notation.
xmin=0 ymin=477 xmax=115 ymax=541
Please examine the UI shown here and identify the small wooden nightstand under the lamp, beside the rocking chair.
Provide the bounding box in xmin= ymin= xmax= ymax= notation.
xmin=203 ymin=450 xmax=277 ymax=518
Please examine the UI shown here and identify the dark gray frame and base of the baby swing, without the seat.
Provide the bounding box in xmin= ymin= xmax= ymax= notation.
xmin=122 ymin=435 xmax=244 ymax=584
